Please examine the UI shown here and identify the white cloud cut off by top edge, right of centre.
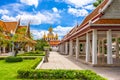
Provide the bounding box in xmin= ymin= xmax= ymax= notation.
xmin=64 ymin=0 xmax=96 ymax=8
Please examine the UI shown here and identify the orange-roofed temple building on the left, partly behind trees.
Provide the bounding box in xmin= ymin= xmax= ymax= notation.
xmin=0 ymin=20 xmax=36 ymax=54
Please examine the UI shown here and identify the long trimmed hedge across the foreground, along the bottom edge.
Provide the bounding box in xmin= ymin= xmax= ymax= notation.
xmin=18 ymin=69 xmax=107 ymax=80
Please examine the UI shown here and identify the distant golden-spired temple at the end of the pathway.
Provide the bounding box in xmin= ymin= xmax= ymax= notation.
xmin=43 ymin=27 xmax=60 ymax=50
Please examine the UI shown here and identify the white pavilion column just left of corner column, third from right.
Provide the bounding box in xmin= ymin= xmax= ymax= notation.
xmin=86 ymin=33 xmax=90 ymax=62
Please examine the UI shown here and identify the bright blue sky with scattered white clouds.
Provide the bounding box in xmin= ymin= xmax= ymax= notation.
xmin=0 ymin=0 xmax=96 ymax=39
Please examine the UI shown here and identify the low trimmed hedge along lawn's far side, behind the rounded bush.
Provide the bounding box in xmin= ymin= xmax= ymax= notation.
xmin=18 ymin=51 xmax=45 ymax=56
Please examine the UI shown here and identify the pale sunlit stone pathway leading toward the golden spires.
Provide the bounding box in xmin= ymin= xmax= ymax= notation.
xmin=41 ymin=52 xmax=81 ymax=69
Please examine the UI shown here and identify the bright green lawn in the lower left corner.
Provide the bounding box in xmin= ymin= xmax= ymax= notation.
xmin=0 ymin=59 xmax=34 ymax=80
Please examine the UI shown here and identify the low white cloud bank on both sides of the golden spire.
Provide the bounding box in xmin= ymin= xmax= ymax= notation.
xmin=31 ymin=26 xmax=73 ymax=39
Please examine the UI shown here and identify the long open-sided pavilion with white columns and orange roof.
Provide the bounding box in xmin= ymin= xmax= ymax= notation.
xmin=59 ymin=0 xmax=120 ymax=66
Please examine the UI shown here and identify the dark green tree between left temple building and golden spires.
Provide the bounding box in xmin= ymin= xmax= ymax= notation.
xmin=35 ymin=39 xmax=49 ymax=51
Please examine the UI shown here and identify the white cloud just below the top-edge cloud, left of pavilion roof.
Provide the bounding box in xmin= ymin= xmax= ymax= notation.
xmin=68 ymin=7 xmax=88 ymax=17
